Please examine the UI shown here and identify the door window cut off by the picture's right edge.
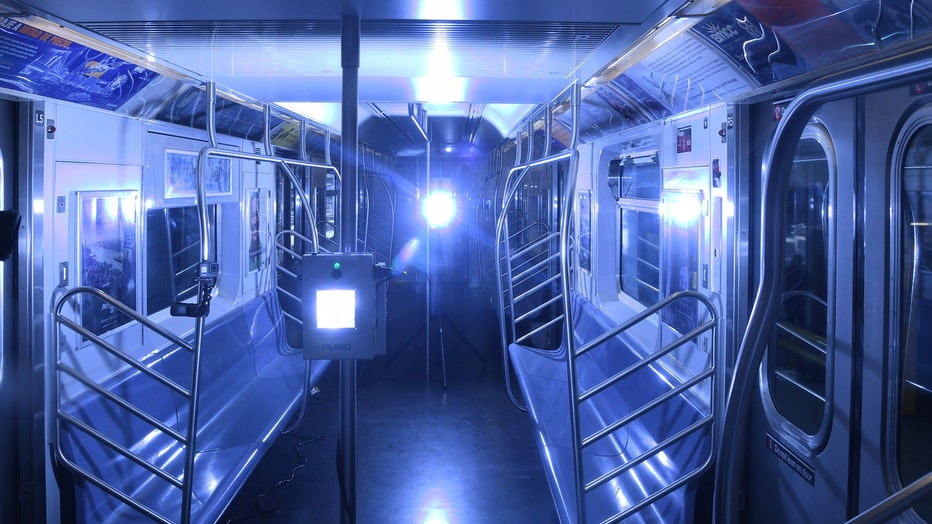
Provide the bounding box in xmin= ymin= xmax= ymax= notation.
xmin=896 ymin=125 xmax=932 ymax=521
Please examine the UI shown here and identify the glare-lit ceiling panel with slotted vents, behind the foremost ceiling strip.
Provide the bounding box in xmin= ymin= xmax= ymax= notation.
xmin=84 ymin=20 xmax=617 ymax=86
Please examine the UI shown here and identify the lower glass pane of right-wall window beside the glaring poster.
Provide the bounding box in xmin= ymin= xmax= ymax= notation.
xmin=621 ymin=209 xmax=660 ymax=306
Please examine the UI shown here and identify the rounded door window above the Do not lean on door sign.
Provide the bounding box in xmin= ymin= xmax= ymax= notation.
xmin=767 ymin=134 xmax=832 ymax=436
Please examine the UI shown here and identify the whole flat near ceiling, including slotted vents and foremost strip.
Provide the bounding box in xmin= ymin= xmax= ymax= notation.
xmin=7 ymin=0 xmax=689 ymax=151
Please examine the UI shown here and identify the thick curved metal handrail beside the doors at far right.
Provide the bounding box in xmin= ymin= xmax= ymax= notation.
xmin=713 ymin=50 xmax=932 ymax=524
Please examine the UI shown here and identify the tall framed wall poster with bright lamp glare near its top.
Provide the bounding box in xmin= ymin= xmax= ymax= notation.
xmin=661 ymin=191 xmax=703 ymax=334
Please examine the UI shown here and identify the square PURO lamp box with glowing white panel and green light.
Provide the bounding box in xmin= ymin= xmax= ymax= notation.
xmin=302 ymin=253 xmax=377 ymax=360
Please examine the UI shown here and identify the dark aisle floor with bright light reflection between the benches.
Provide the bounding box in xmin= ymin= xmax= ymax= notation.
xmin=221 ymin=284 xmax=558 ymax=524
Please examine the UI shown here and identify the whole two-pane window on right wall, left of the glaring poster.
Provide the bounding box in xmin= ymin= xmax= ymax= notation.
xmin=613 ymin=153 xmax=661 ymax=306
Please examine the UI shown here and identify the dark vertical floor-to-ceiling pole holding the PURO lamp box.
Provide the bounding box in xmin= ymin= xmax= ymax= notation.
xmin=338 ymin=9 xmax=359 ymax=524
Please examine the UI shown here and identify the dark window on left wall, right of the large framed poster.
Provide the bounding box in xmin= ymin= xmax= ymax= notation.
xmin=146 ymin=205 xmax=217 ymax=315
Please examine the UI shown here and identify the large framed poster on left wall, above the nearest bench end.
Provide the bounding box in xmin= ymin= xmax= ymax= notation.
xmin=77 ymin=191 xmax=139 ymax=335
